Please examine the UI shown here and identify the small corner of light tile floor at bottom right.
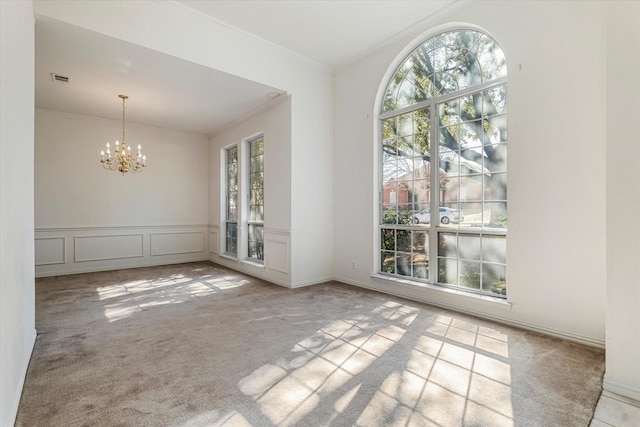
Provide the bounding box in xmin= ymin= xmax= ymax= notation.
xmin=591 ymin=391 xmax=640 ymax=427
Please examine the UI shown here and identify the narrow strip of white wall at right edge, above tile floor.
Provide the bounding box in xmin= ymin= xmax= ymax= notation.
xmin=604 ymin=2 xmax=640 ymax=400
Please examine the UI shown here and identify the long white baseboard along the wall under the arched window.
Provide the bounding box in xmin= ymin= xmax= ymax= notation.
xmin=335 ymin=277 xmax=605 ymax=349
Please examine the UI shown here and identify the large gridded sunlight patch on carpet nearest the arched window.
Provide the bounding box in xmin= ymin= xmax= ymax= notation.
xmin=238 ymin=301 xmax=514 ymax=427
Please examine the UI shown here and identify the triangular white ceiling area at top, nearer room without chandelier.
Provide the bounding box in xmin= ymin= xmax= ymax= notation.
xmin=178 ymin=0 xmax=456 ymax=68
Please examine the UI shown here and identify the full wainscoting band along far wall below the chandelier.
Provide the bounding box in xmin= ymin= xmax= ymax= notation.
xmin=35 ymin=225 xmax=209 ymax=277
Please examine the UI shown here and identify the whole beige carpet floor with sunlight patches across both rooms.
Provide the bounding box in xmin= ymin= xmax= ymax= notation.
xmin=16 ymin=262 xmax=604 ymax=427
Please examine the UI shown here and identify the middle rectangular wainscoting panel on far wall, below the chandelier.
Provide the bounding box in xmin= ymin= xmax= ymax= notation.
xmin=74 ymin=234 xmax=144 ymax=262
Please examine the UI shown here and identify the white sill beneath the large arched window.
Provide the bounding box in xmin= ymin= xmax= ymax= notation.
xmin=371 ymin=273 xmax=512 ymax=311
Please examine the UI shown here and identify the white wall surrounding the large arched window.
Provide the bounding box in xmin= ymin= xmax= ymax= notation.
xmin=334 ymin=1 xmax=606 ymax=346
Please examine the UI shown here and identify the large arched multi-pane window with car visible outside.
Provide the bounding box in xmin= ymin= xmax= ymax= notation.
xmin=379 ymin=29 xmax=507 ymax=297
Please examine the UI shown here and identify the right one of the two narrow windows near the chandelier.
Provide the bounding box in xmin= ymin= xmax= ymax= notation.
xmin=247 ymin=136 xmax=264 ymax=261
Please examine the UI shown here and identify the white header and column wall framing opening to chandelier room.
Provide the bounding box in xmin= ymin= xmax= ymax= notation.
xmin=34 ymin=1 xmax=333 ymax=286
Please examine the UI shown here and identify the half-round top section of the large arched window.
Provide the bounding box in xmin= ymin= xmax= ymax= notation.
xmin=382 ymin=29 xmax=507 ymax=113
